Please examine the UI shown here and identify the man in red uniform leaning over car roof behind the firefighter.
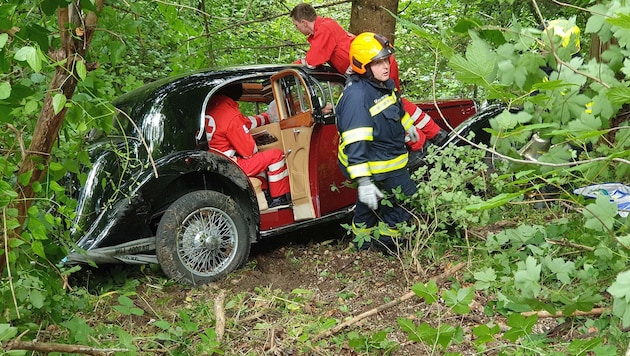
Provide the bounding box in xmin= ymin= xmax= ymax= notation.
xmin=291 ymin=3 xmax=447 ymax=166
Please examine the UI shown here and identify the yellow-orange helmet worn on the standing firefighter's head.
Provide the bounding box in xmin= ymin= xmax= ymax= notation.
xmin=349 ymin=32 xmax=394 ymax=74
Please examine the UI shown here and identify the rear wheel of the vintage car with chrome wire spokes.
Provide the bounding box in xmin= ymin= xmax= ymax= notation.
xmin=156 ymin=190 xmax=251 ymax=286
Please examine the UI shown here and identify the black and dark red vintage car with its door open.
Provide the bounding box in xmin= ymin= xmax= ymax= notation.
xmin=66 ymin=65 xmax=496 ymax=285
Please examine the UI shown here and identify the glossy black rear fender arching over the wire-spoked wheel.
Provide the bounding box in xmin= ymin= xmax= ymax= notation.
xmin=72 ymin=150 xmax=260 ymax=250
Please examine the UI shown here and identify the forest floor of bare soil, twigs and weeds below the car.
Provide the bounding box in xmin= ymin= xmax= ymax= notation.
xmin=76 ymin=221 xmax=558 ymax=355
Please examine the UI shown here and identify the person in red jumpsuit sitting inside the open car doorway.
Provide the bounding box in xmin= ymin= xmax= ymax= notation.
xmin=206 ymin=84 xmax=290 ymax=208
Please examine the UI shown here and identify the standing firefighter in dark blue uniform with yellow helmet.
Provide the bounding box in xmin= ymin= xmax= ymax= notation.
xmin=337 ymin=32 xmax=418 ymax=250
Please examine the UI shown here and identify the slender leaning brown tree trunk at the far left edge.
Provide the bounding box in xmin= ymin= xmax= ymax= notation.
xmin=0 ymin=0 xmax=104 ymax=272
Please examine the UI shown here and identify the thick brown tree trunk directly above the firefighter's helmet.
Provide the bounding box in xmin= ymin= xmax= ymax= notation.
xmin=349 ymin=0 xmax=398 ymax=44
